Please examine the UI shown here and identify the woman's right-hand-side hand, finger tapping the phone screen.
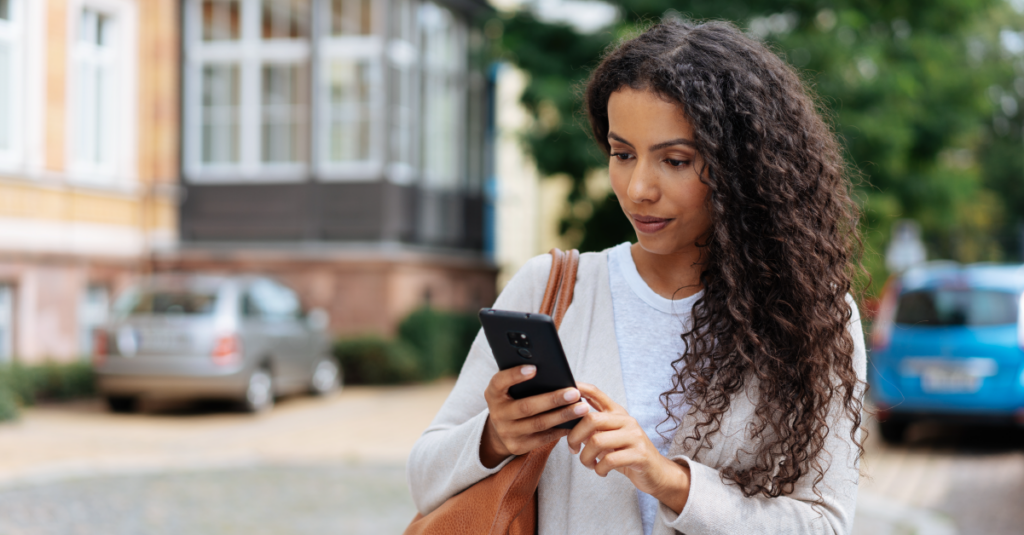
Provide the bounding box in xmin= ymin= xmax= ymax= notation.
xmin=566 ymin=382 xmax=690 ymax=513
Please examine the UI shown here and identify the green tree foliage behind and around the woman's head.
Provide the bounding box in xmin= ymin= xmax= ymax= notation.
xmin=494 ymin=0 xmax=1024 ymax=291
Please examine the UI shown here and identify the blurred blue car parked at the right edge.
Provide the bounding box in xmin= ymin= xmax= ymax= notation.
xmin=868 ymin=262 xmax=1024 ymax=443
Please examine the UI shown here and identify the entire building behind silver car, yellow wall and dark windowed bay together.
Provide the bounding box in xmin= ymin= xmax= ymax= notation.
xmin=0 ymin=0 xmax=497 ymax=363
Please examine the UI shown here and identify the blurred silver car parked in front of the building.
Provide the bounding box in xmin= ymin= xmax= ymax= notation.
xmin=94 ymin=275 xmax=341 ymax=412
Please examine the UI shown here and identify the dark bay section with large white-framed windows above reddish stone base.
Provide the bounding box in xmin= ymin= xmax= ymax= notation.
xmin=154 ymin=0 xmax=497 ymax=334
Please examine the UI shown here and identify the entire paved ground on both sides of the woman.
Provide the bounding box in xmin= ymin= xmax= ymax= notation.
xmin=0 ymin=382 xmax=1024 ymax=535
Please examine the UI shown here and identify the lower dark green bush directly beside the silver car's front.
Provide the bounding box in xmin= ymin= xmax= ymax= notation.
xmin=334 ymin=336 xmax=419 ymax=384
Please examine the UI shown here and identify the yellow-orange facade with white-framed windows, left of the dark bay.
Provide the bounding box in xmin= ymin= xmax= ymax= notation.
xmin=0 ymin=0 xmax=179 ymax=362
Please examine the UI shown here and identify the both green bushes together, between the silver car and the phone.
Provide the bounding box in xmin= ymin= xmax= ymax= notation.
xmin=334 ymin=307 xmax=480 ymax=384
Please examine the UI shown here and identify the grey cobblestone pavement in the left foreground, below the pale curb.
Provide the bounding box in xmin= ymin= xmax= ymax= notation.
xmin=0 ymin=464 xmax=416 ymax=535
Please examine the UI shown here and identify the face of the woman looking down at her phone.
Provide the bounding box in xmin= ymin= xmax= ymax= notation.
xmin=608 ymin=87 xmax=711 ymax=254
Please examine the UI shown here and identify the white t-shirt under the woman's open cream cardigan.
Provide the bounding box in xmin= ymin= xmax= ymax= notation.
xmin=608 ymin=242 xmax=703 ymax=535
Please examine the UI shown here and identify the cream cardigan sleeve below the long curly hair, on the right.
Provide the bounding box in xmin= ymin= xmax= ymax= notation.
xmin=658 ymin=295 xmax=866 ymax=535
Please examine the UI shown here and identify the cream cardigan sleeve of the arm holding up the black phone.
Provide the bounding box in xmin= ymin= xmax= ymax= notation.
xmin=407 ymin=254 xmax=551 ymax=515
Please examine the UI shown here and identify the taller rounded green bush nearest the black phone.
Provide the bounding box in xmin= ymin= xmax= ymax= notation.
xmin=398 ymin=307 xmax=480 ymax=380
